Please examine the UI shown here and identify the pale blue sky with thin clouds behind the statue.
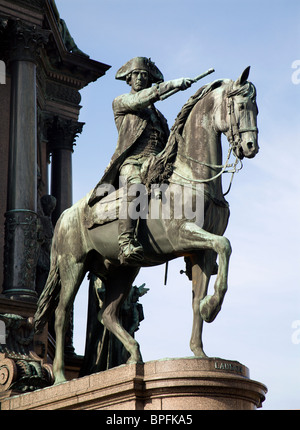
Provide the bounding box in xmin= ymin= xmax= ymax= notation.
xmin=56 ymin=0 xmax=300 ymax=410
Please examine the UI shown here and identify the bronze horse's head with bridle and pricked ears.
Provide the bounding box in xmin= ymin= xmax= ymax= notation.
xmin=216 ymin=67 xmax=259 ymax=159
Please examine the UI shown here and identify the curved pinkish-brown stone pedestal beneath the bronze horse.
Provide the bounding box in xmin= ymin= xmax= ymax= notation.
xmin=1 ymin=357 xmax=267 ymax=411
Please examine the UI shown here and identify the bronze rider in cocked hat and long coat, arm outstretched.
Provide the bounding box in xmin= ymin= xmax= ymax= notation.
xmin=89 ymin=57 xmax=192 ymax=264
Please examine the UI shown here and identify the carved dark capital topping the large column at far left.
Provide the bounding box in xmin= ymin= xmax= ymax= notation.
xmin=6 ymin=19 xmax=51 ymax=63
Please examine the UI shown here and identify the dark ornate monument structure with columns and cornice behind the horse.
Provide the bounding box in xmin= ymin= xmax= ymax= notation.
xmin=0 ymin=0 xmax=110 ymax=397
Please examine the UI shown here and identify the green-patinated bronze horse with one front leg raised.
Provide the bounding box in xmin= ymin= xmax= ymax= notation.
xmin=34 ymin=67 xmax=259 ymax=384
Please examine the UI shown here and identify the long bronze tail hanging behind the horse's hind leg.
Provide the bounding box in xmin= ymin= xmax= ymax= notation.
xmin=34 ymin=235 xmax=61 ymax=333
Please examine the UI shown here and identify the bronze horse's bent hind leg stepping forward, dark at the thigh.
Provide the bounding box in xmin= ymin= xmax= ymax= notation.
xmin=102 ymin=266 xmax=142 ymax=363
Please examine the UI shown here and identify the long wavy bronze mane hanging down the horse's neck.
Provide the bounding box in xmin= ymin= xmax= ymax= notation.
xmin=141 ymin=79 xmax=224 ymax=190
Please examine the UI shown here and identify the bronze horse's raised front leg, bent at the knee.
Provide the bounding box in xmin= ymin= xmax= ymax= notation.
xmin=176 ymin=222 xmax=231 ymax=322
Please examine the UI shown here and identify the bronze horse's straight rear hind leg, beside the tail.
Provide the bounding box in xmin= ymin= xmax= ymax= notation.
xmin=53 ymin=257 xmax=85 ymax=384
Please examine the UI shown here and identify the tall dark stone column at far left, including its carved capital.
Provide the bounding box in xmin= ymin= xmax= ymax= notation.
xmin=3 ymin=21 xmax=49 ymax=301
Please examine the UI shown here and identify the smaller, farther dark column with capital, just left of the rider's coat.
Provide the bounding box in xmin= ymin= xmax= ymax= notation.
xmin=47 ymin=116 xmax=83 ymax=225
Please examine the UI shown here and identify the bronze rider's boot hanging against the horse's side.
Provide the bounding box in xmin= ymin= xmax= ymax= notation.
xmin=119 ymin=217 xmax=144 ymax=265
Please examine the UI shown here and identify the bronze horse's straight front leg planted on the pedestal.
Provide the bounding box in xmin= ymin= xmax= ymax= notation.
xmin=190 ymin=251 xmax=215 ymax=357
